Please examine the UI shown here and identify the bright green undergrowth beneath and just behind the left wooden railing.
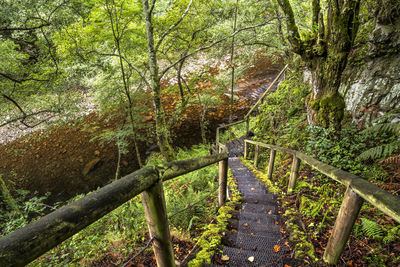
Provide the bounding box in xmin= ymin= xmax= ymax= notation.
xmin=15 ymin=145 xmax=218 ymax=266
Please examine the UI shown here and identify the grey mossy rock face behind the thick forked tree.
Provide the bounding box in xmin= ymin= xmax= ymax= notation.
xmin=340 ymin=0 xmax=400 ymax=126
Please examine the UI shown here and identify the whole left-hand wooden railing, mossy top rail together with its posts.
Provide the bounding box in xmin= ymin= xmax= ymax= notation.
xmin=0 ymin=152 xmax=228 ymax=266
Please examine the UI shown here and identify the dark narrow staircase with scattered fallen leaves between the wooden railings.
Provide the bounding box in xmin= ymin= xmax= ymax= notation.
xmin=217 ymin=137 xmax=286 ymax=266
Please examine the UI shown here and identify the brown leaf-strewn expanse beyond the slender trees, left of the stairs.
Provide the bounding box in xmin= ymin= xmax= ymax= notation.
xmin=0 ymin=54 xmax=281 ymax=204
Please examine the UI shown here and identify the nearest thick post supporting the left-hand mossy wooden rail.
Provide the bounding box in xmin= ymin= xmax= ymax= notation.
xmin=141 ymin=181 xmax=175 ymax=267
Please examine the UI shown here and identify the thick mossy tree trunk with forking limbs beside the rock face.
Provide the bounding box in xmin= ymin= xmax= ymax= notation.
xmin=277 ymin=0 xmax=360 ymax=129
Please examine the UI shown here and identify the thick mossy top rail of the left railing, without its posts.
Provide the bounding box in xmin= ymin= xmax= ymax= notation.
xmin=0 ymin=152 xmax=228 ymax=266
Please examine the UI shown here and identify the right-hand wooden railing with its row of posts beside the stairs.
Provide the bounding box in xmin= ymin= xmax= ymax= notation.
xmin=244 ymin=140 xmax=400 ymax=264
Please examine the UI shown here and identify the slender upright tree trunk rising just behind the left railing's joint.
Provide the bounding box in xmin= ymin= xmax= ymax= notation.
xmin=142 ymin=0 xmax=174 ymax=161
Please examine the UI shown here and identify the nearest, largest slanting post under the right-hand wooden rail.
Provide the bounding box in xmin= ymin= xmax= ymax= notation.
xmin=324 ymin=187 xmax=364 ymax=264
